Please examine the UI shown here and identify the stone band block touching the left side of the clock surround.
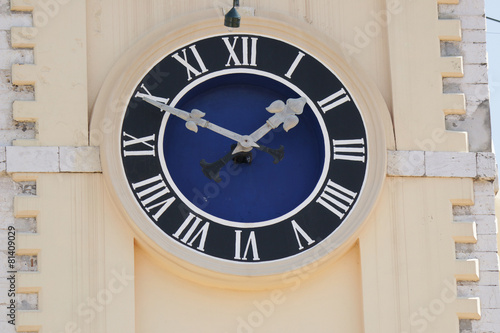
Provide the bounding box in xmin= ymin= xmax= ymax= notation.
xmin=60 ymin=147 xmax=102 ymax=172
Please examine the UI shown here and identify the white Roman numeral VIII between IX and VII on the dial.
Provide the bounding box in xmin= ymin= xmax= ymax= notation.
xmin=132 ymin=175 xmax=175 ymax=221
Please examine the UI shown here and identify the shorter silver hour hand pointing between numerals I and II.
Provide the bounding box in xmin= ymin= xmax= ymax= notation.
xmin=249 ymin=97 xmax=307 ymax=142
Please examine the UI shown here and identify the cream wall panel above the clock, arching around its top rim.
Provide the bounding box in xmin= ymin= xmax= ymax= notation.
xmin=87 ymin=0 xmax=392 ymax=115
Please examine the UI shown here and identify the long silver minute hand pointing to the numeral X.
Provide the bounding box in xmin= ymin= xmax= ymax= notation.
xmin=135 ymin=92 xmax=259 ymax=148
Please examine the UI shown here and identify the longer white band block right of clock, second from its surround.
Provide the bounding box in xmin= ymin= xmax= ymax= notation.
xmin=425 ymin=152 xmax=476 ymax=178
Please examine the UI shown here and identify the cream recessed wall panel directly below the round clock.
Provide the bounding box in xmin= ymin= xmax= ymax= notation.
xmin=135 ymin=246 xmax=364 ymax=333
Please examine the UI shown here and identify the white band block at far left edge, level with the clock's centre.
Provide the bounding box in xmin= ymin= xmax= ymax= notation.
xmin=7 ymin=146 xmax=59 ymax=172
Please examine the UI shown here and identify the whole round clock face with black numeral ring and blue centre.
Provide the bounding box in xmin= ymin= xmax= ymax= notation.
xmin=120 ymin=34 xmax=370 ymax=265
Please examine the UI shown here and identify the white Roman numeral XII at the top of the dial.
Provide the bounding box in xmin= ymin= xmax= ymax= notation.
xmin=222 ymin=36 xmax=259 ymax=67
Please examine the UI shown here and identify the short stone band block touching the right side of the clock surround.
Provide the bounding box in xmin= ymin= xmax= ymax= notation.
xmin=387 ymin=150 xmax=425 ymax=177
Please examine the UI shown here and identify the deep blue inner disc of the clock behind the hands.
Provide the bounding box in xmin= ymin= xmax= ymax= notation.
xmin=163 ymin=74 xmax=325 ymax=222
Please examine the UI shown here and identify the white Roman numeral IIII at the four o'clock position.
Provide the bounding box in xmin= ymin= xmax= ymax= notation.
xmin=316 ymin=180 xmax=358 ymax=218
